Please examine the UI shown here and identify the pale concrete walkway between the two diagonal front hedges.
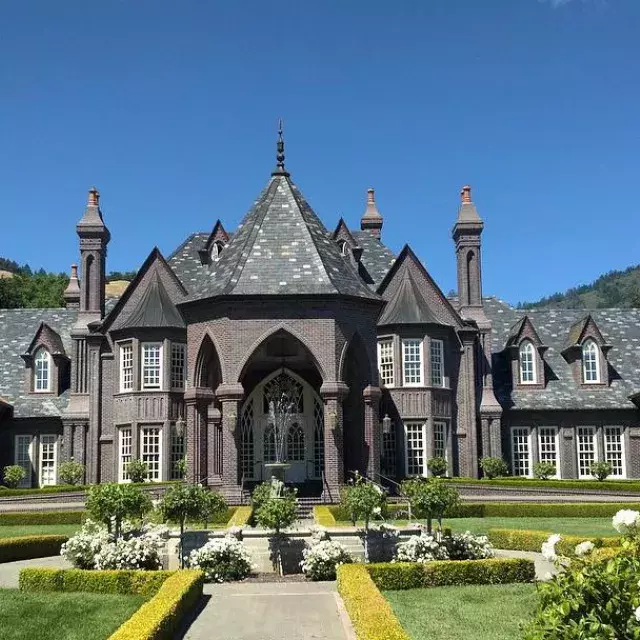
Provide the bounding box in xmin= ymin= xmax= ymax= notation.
xmin=184 ymin=582 xmax=355 ymax=640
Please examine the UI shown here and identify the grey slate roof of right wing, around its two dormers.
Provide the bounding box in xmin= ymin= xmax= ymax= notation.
xmin=484 ymin=298 xmax=640 ymax=409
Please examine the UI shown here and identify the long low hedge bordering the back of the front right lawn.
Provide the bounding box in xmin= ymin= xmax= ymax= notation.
xmin=367 ymin=558 xmax=535 ymax=591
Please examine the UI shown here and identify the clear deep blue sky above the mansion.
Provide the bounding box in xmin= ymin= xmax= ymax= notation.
xmin=0 ymin=0 xmax=640 ymax=302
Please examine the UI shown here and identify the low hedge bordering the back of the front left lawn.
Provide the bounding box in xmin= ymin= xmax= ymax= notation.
xmin=19 ymin=568 xmax=175 ymax=598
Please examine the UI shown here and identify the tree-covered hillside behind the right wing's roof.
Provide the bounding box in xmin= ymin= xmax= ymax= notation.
xmin=518 ymin=265 xmax=640 ymax=309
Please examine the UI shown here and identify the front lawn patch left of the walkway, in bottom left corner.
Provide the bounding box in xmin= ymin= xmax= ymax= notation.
xmin=0 ymin=589 xmax=144 ymax=640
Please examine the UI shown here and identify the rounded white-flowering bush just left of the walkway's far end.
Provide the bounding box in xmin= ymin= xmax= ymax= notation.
xmin=187 ymin=536 xmax=253 ymax=582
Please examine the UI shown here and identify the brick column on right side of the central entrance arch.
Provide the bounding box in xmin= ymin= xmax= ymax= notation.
xmin=320 ymin=382 xmax=349 ymax=502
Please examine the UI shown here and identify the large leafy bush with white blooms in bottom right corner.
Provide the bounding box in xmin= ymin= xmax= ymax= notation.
xmin=523 ymin=509 xmax=640 ymax=640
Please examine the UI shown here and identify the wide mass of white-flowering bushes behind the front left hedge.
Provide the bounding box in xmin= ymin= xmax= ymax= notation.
xmin=60 ymin=520 xmax=167 ymax=571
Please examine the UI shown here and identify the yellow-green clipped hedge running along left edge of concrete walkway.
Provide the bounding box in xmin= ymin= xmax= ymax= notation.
xmin=109 ymin=569 xmax=204 ymax=640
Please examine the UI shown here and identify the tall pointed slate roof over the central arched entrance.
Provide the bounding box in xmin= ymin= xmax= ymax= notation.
xmin=182 ymin=174 xmax=381 ymax=301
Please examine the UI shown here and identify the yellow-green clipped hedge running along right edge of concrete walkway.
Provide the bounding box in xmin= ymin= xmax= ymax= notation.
xmin=337 ymin=564 xmax=410 ymax=640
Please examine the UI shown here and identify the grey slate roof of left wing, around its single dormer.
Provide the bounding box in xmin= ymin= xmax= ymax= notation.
xmin=0 ymin=309 xmax=78 ymax=418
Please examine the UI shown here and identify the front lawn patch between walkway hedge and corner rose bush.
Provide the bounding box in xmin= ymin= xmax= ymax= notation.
xmin=384 ymin=584 xmax=536 ymax=640
